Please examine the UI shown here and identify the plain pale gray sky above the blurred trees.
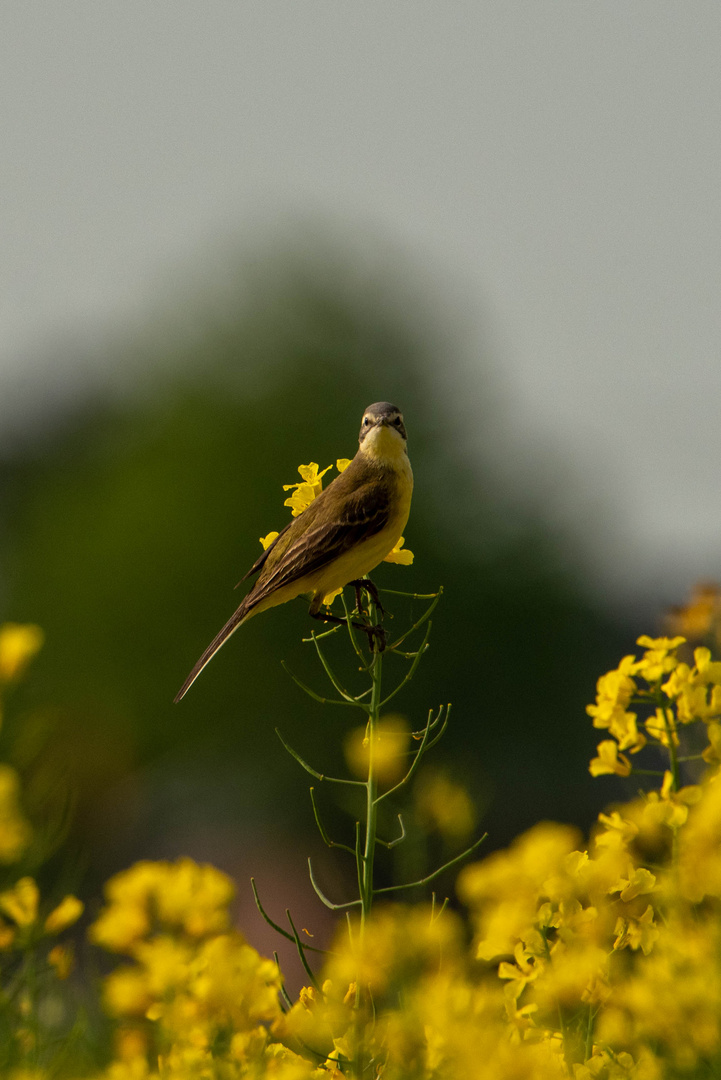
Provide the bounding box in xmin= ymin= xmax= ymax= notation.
xmin=0 ymin=6 xmax=721 ymax=617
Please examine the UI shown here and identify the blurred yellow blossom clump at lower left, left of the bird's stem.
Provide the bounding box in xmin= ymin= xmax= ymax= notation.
xmin=89 ymin=859 xmax=327 ymax=1080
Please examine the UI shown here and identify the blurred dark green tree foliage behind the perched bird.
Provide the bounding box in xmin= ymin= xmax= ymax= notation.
xmin=1 ymin=254 xmax=620 ymax=902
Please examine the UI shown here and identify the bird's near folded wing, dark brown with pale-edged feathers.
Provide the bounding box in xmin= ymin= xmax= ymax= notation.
xmin=247 ymin=482 xmax=391 ymax=607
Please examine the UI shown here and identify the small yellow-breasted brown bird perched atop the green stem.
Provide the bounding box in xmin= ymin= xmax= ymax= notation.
xmin=175 ymin=402 xmax=413 ymax=702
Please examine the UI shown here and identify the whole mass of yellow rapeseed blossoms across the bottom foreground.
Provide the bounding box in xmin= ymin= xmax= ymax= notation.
xmin=9 ymin=604 xmax=721 ymax=1080
